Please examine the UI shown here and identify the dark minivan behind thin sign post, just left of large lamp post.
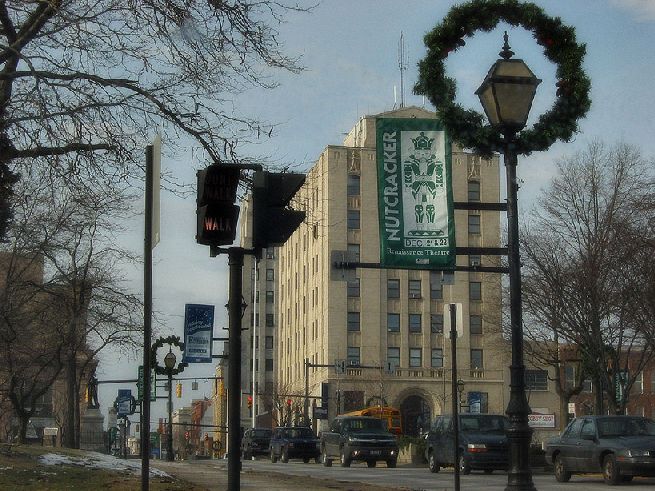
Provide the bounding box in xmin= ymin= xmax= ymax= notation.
xmin=425 ymin=414 xmax=509 ymax=474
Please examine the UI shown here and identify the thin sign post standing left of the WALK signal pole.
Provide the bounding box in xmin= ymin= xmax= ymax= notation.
xmin=141 ymin=145 xmax=154 ymax=491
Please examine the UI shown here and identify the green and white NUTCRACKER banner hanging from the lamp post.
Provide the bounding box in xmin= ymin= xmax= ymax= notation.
xmin=376 ymin=118 xmax=455 ymax=270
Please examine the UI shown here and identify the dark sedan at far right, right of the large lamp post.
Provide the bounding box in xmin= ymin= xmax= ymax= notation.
xmin=546 ymin=416 xmax=655 ymax=485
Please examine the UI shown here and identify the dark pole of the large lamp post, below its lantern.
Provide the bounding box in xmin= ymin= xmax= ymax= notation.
xmin=505 ymin=142 xmax=536 ymax=491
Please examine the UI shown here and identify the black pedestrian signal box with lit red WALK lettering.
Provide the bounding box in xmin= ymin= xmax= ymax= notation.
xmin=196 ymin=164 xmax=241 ymax=246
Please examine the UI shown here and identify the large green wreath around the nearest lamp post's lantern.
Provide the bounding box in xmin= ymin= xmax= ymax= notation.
xmin=414 ymin=0 xmax=591 ymax=157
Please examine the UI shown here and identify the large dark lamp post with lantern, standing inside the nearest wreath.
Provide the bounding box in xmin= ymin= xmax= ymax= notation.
xmin=475 ymin=32 xmax=541 ymax=491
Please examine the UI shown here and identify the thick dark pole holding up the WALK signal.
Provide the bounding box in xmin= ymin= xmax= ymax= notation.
xmin=227 ymin=247 xmax=244 ymax=491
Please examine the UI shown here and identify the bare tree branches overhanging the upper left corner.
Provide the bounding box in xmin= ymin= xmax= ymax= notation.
xmin=0 ymin=0 xmax=305 ymax=238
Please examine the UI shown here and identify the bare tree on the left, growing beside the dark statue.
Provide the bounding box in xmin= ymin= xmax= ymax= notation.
xmin=4 ymin=164 xmax=142 ymax=447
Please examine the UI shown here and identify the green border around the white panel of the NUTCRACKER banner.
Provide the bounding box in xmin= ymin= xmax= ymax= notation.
xmin=376 ymin=118 xmax=457 ymax=271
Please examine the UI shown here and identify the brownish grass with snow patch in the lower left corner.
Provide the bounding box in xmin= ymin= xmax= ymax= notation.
xmin=0 ymin=445 xmax=204 ymax=491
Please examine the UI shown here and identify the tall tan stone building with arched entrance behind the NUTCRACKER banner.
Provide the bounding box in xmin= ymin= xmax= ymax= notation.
xmin=236 ymin=107 xmax=509 ymax=434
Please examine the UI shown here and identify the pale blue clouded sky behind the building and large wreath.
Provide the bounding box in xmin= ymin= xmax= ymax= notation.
xmin=98 ymin=0 xmax=655 ymax=428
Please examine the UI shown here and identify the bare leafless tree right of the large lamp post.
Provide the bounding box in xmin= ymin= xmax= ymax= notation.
xmin=523 ymin=143 xmax=653 ymax=412
